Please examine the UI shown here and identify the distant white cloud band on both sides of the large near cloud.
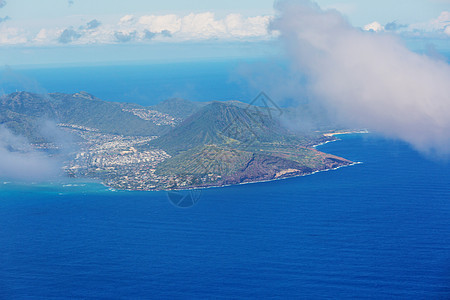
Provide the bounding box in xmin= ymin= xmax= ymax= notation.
xmin=0 ymin=11 xmax=450 ymax=46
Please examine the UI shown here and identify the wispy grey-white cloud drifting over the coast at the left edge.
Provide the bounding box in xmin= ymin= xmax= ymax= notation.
xmin=0 ymin=66 xmax=78 ymax=181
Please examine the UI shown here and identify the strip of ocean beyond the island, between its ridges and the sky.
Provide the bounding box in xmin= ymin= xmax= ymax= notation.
xmin=0 ymin=60 xmax=259 ymax=105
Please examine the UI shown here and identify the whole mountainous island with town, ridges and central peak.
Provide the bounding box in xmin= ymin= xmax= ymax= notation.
xmin=0 ymin=92 xmax=353 ymax=191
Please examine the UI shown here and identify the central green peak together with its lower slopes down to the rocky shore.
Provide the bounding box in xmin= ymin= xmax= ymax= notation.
xmin=149 ymin=102 xmax=351 ymax=189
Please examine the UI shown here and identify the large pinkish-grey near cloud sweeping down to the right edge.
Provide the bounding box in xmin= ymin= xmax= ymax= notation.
xmin=272 ymin=1 xmax=450 ymax=155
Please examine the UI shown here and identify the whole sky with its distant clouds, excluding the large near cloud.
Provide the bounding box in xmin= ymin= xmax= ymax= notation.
xmin=0 ymin=0 xmax=450 ymax=65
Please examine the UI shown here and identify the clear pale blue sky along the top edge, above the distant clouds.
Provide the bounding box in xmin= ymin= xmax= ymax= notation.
xmin=2 ymin=0 xmax=450 ymax=26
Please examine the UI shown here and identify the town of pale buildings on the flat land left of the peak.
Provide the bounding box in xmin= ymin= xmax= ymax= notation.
xmin=58 ymin=124 xmax=171 ymax=190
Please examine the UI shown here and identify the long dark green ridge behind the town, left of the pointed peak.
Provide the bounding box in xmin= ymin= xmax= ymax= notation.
xmin=0 ymin=92 xmax=178 ymax=141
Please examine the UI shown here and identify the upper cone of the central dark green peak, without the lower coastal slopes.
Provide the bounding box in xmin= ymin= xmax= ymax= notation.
xmin=151 ymin=102 xmax=316 ymax=155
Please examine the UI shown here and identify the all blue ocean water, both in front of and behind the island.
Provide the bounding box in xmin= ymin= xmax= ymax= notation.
xmin=0 ymin=62 xmax=450 ymax=299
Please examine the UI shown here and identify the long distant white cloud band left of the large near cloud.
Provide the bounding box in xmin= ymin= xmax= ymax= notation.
xmin=0 ymin=12 xmax=275 ymax=46
